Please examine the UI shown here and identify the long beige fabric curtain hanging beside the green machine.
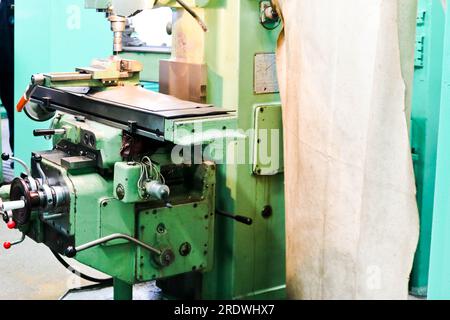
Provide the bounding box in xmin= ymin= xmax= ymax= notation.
xmin=277 ymin=0 xmax=419 ymax=299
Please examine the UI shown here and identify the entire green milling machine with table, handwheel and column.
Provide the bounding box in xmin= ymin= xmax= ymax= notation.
xmin=0 ymin=0 xmax=285 ymax=299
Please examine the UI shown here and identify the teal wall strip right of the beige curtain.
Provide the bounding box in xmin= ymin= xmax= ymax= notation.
xmin=411 ymin=0 xmax=450 ymax=299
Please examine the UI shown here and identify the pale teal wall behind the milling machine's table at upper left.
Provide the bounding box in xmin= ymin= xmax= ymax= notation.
xmin=15 ymin=0 xmax=112 ymax=172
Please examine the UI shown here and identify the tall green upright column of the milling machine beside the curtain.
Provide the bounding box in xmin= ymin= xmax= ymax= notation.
xmin=203 ymin=0 xmax=285 ymax=299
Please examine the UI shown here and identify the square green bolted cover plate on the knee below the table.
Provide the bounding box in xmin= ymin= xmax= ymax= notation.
xmin=137 ymin=176 xmax=215 ymax=281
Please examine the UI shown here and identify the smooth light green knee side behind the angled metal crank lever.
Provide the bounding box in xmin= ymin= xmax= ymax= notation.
xmin=69 ymin=173 xmax=136 ymax=284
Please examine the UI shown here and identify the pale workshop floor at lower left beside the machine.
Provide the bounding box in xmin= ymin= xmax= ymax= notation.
xmin=0 ymin=120 xmax=104 ymax=300
